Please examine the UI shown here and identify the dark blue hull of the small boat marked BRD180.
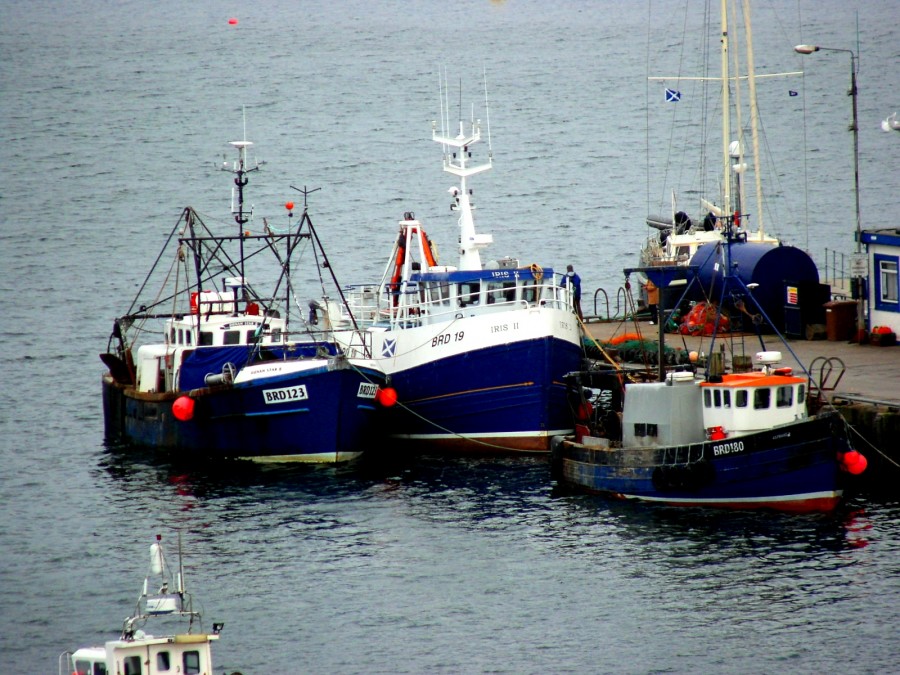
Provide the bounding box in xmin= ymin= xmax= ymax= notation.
xmin=554 ymin=414 xmax=849 ymax=512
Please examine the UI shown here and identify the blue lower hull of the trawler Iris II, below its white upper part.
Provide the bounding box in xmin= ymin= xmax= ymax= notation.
xmin=389 ymin=338 xmax=582 ymax=452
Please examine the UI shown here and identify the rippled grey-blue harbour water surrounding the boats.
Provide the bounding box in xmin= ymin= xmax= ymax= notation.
xmin=0 ymin=0 xmax=900 ymax=673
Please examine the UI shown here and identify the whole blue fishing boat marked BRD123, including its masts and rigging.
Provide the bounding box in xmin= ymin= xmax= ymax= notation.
xmin=100 ymin=141 xmax=385 ymax=462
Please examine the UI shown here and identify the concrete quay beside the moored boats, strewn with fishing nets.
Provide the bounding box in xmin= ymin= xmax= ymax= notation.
xmin=584 ymin=319 xmax=900 ymax=495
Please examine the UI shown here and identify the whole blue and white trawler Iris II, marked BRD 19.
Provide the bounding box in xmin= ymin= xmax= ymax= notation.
xmin=333 ymin=84 xmax=583 ymax=453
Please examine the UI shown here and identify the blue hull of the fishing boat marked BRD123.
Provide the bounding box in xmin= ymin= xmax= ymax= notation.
xmin=103 ymin=367 xmax=384 ymax=462
